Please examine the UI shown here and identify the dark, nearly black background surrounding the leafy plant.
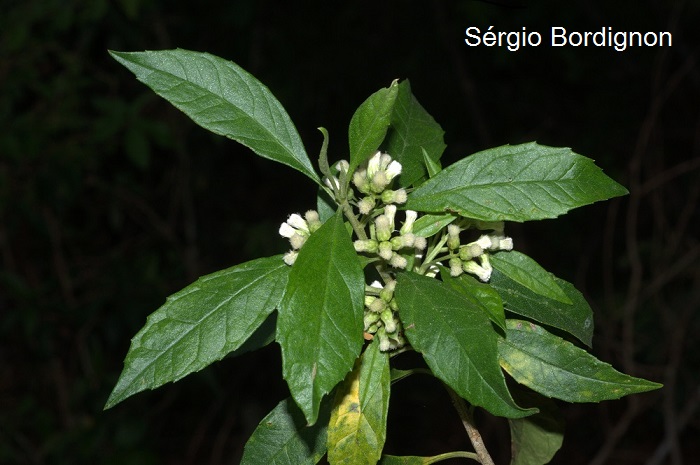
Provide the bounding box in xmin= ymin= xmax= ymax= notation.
xmin=0 ymin=0 xmax=700 ymax=464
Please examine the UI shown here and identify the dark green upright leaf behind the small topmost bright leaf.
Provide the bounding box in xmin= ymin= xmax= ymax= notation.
xmin=385 ymin=80 xmax=445 ymax=187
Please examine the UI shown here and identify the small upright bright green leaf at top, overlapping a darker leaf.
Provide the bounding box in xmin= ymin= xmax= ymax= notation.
xmin=348 ymin=81 xmax=399 ymax=173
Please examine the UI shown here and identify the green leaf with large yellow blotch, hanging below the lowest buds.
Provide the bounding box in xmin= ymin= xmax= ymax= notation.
xmin=328 ymin=342 xmax=391 ymax=465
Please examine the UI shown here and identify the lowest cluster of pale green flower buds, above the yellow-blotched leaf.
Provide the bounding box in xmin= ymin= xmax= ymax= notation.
xmin=364 ymin=280 xmax=406 ymax=352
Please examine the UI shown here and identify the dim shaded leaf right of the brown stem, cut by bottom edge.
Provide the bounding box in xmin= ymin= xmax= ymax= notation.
xmin=508 ymin=391 xmax=564 ymax=465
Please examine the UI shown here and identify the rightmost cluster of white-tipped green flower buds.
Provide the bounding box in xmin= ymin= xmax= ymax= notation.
xmin=447 ymin=224 xmax=513 ymax=282
